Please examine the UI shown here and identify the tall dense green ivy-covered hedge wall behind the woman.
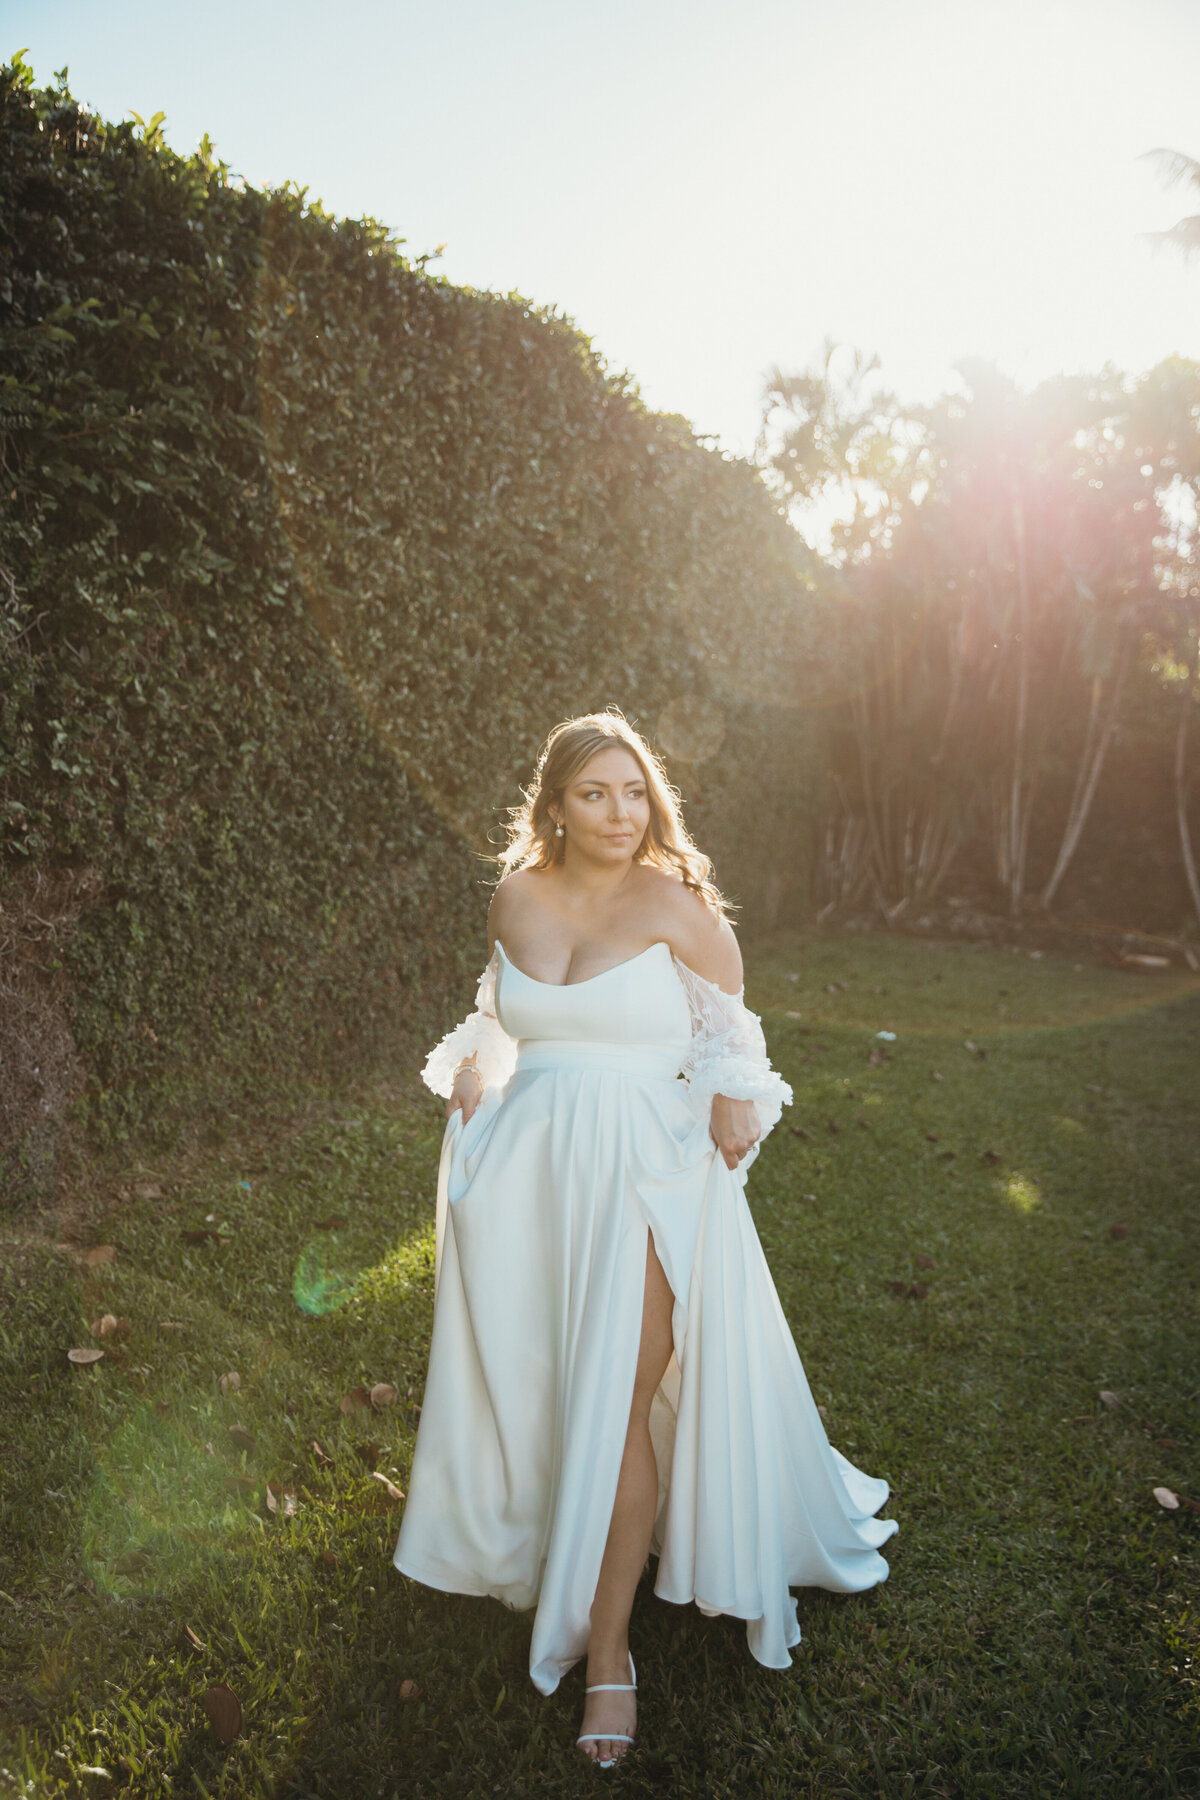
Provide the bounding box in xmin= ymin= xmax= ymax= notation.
xmin=0 ymin=63 xmax=819 ymax=1166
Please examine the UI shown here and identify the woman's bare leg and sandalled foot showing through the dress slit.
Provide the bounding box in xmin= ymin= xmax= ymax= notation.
xmin=579 ymin=1231 xmax=675 ymax=1762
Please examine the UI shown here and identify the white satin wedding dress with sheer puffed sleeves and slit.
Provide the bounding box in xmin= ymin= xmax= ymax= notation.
xmin=394 ymin=943 xmax=898 ymax=1694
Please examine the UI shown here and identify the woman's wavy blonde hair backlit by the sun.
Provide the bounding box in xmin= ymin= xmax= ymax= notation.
xmin=497 ymin=706 xmax=729 ymax=918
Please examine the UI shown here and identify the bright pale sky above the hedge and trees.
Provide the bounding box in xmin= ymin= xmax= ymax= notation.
xmin=9 ymin=0 xmax=1200 ymax=455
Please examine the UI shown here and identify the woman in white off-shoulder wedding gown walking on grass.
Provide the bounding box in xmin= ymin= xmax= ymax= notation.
xmin=394 ymin=709 xmax=898 ymax=1768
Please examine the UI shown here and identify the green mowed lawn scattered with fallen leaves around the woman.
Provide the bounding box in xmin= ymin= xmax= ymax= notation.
xmin=0 ymin=936 xmax=1200 ymax=1800
